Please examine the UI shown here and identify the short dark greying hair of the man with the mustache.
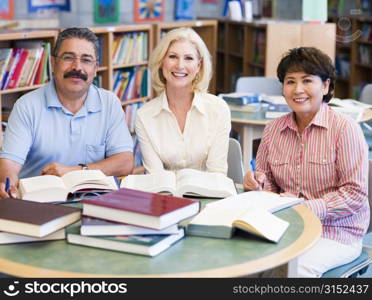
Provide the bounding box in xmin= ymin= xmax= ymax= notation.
xmin=53 ymin=27 xmax=99 ymax=59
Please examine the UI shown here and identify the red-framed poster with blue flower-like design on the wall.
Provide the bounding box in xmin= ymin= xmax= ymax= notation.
xmin=134 ymin=0 xmax=164 ymax=22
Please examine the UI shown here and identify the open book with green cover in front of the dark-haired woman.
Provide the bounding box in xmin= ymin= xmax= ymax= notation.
xmin=186 ymin=191 xmax=304 ymax=242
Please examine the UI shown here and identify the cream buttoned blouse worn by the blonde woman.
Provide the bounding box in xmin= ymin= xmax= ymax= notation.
xmin=135 ymin=92 xmax=231 ymax=174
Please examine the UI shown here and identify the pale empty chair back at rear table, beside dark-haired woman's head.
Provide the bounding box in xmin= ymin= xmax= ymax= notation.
xmin=235 ymin=77 xmax=282 ymax=96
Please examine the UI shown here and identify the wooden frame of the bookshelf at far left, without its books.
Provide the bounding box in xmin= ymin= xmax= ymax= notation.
xmin=0 ymin=30 xmax=58 ymax=145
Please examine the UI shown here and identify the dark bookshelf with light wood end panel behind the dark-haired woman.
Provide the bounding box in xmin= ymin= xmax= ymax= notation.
xmin=216 ymin=19 xmax=336 ymax=94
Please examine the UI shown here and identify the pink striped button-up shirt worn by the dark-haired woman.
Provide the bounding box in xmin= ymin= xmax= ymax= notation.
xmin=257 ymin=103 xmax=370 ymax=244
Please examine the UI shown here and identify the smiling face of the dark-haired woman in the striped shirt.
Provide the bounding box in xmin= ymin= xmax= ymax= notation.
xmin=283 ymin=72 xmax=329 ymax=120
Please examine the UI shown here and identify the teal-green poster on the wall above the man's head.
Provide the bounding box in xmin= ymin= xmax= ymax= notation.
xmin=94 ymin=0 xmax=120 ymax=23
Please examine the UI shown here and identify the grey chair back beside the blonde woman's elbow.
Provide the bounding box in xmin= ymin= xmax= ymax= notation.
xmin=227 ymin=138 xmax=244 ymax=183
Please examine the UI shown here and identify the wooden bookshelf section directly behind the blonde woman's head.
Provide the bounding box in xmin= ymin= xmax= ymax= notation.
xmin=153 ymin=20 xmax=217 ymax=93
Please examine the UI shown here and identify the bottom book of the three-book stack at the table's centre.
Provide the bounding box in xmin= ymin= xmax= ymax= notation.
xmin=66 ymin=226 xmax=184 ymax=256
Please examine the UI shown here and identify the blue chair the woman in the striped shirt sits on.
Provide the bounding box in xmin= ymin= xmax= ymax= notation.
xmin=322 ymin=159 xmax=372 ymax=278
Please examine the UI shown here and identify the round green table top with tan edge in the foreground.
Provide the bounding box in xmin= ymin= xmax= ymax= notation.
xmin=0 ymin=205 xmax=320 ymax=277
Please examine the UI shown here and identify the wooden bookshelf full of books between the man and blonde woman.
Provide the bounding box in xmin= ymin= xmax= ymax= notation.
xmin=90 ymin=24 xmax=154 ymax=174
